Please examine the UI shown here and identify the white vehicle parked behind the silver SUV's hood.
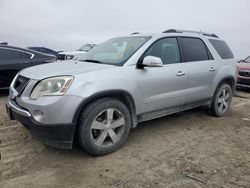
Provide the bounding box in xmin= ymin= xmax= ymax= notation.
xmin=57 ymin=44 xmax=96 ymax=60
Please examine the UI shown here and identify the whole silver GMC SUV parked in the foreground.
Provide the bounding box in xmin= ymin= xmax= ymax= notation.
xmin=6 ymin=29 xmax=237 ymax=155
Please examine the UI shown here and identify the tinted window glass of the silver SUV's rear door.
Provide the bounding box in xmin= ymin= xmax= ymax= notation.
xmin=181 ymin=37 xmax=210 ymax=62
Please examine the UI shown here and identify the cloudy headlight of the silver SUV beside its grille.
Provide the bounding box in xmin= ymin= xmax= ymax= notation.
xmin=30 ymin=76 xmax=74 ymax=100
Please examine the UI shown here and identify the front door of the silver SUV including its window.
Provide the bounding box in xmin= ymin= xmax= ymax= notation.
xmin=138 ymin=37 xmax=187 ymax=114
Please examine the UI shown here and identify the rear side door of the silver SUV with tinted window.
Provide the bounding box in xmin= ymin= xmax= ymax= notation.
xmin=179 ymin=37 xmax=217 ymax=107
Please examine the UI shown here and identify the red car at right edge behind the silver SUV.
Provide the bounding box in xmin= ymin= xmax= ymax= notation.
xmin=237 ymin=56 xmax=250 ymax=88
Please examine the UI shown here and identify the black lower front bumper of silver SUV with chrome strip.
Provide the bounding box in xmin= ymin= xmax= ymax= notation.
xmin=6 ymin=98 xmax=76 ymax=149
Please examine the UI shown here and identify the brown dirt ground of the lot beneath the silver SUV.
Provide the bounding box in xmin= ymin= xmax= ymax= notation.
xmin=0 ymin=91 xmax=250 ymax=188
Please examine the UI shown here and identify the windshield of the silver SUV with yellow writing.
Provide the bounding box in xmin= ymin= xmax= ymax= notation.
xmin=78 ymin=37 xmax=150 ymax=66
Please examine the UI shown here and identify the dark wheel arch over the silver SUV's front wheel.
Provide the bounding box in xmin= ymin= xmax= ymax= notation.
xmin=73 ymin=90 xmax=137 ymax=128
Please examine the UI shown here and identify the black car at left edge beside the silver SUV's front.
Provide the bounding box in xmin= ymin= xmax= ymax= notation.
xmin=0 ymin=45 xmax=56 ymax=89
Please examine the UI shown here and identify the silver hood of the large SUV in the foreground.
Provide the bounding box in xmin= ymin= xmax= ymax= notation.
xmin=19 ymin=61 xmax=115 ymax=80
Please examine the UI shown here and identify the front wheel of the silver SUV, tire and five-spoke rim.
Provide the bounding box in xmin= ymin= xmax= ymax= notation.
xmin=78 ymin=98 xmax=131 ymax=156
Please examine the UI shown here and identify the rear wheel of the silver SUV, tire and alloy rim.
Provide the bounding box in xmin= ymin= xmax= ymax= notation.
xmin=210 ymin=83 xmax=233 ymax=117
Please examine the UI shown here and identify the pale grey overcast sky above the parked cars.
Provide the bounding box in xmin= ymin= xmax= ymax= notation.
xmin=0 ymin=0 xmax=250 ymax=58
